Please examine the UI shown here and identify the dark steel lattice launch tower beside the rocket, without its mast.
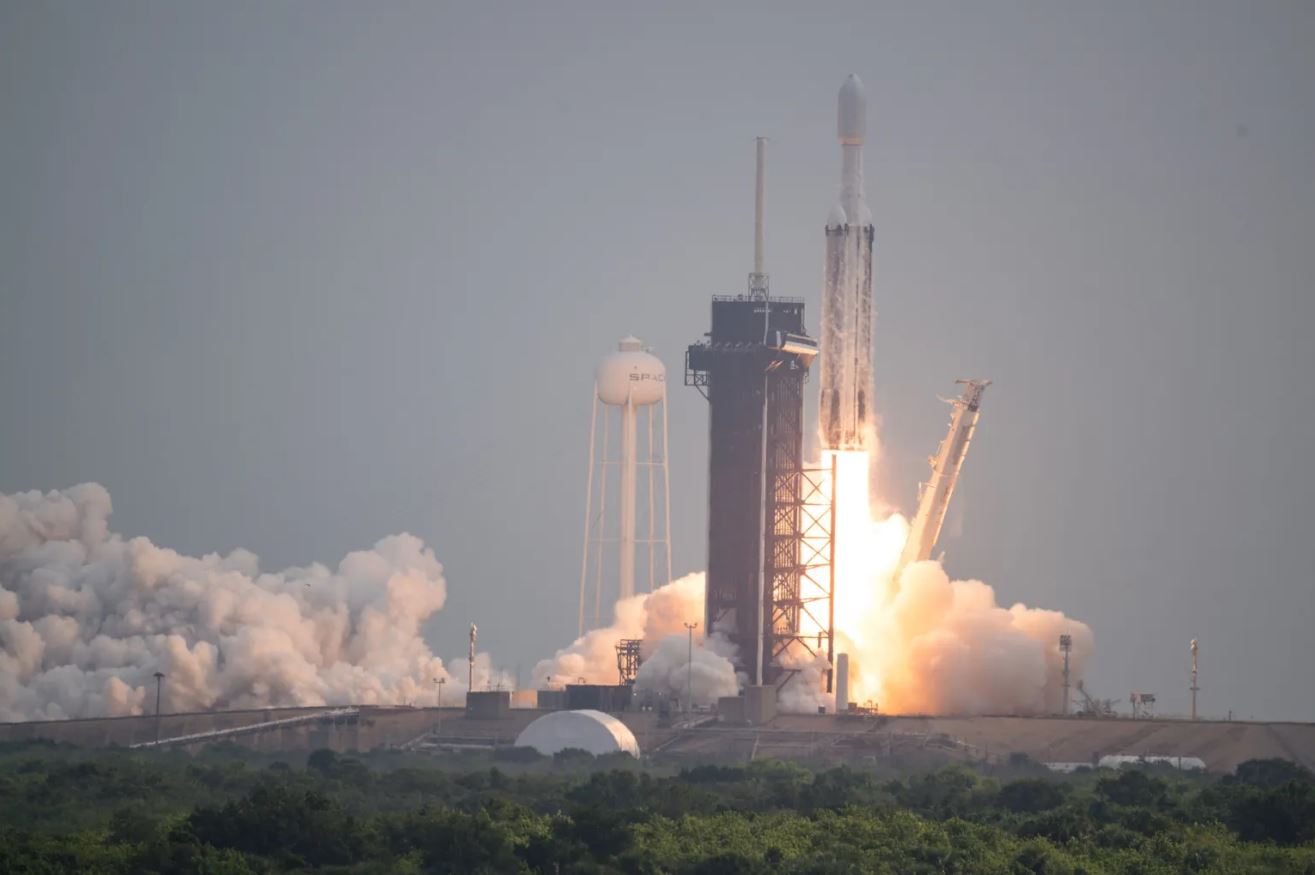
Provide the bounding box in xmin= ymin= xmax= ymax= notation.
xmin=685 ymin=297 xmax=832 ymax=684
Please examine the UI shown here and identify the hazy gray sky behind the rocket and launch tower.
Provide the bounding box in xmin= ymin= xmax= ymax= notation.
xmin=0 ymin=0 xmax=1315 ymax=720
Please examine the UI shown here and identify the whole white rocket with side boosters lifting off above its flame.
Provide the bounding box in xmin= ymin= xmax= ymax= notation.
xmin=818 ymin=74 xmax=874 ymax=450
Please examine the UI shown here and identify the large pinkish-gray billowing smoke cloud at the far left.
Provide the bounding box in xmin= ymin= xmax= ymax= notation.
xmin=0 ymin=483 xmax=505 ymax=720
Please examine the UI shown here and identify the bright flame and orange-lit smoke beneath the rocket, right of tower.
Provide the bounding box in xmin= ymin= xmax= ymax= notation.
xmin=820 ymin=453 xmax=1093 ymax=714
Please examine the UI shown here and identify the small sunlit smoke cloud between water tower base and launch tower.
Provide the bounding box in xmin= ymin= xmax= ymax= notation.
xmin=534 ymin=572 xmax=739 ymax=705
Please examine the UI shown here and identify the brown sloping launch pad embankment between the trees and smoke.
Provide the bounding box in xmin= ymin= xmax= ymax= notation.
xmin=0 ymin=701 xmax=1315 ymax=772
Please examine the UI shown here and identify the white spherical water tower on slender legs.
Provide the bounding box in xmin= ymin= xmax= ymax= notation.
xmin=580 ymin=337 xmax=671 ymax=634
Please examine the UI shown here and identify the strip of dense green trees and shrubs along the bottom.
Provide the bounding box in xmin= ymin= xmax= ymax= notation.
xmin=0 ymin=743 xmax=1315 ymax=875
